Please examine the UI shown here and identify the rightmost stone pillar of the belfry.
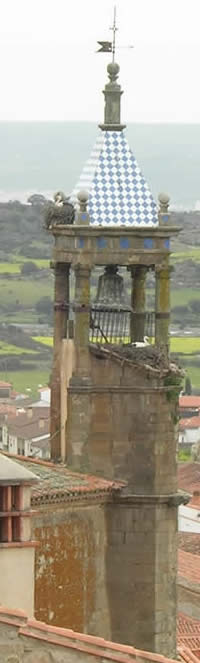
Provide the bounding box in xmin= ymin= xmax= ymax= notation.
xmin=155 ymin=259 xmax=170 ymax=350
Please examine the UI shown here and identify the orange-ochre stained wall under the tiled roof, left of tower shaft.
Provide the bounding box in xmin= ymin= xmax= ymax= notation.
xmin=33 ymin=503 xmax=110 ymax=637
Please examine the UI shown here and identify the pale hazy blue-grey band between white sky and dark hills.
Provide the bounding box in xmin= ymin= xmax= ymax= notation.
xmin=0 ymin=122 xmax=200 ymax=210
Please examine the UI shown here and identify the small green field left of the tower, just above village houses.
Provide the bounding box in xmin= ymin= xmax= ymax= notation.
xmin=0 ymin=369 xmax=50 ymax=397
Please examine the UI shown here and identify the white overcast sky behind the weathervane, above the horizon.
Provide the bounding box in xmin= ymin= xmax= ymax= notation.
xmin=0 ymin=0 xmax=200 ymax=123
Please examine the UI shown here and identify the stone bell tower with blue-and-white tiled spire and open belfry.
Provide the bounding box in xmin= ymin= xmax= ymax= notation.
xmin=47 ymin=36 xmax=184 ymax=657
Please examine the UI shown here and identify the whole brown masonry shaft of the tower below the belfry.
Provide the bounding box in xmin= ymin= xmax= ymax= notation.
xmin=67 ymin=352 xmax=178 ymax=657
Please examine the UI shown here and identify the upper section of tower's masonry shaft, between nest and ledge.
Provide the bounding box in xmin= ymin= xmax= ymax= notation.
xmin=67 ymin=355 xmax=176 ymax=493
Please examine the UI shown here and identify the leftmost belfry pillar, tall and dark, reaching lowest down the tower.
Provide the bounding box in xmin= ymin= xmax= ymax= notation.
xmin=51 ymin=263 xmax=69 ymax=460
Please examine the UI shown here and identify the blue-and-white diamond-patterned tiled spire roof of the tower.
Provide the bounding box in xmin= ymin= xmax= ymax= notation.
xmin=71 ymin=131 xmax=158 ymax=227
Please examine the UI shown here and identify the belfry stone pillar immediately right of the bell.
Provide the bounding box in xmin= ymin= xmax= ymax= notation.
xmin=131 ymin=265 xmax=147 ymax=343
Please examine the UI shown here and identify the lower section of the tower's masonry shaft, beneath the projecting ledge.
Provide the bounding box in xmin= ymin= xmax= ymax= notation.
xmin=106 ymin=495 xmax=181 ymax=659
